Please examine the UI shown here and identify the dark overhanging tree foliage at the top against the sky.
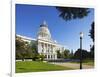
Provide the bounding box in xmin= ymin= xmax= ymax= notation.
xmin=56 ymin=7 xmax=90 ymax=21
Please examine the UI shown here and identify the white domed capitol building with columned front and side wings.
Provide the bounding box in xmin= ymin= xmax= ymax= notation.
xmin=17 ymin=21 xmax=64 ymax=60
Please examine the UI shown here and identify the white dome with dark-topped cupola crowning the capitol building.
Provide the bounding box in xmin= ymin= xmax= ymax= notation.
xmin=38 ymin=21 xmax=51 ymax=40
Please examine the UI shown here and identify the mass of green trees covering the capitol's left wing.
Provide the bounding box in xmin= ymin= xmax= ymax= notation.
xmin=16 ymin=36 xmax=45 ymax=61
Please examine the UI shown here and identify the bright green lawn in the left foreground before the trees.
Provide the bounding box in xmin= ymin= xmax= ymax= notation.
xmin=16 ymin=61 xmax=71 ymax=73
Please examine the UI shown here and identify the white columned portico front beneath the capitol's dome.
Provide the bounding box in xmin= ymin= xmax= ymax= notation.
xmin=38 ymin=41 xmax=57 ymax=60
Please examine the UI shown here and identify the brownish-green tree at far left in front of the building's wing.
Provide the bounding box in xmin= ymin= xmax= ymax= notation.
xmin=16 ymin=36 xmax=33 ymax=61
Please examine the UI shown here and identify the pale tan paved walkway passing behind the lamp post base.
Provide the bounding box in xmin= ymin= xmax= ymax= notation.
xmin=51 ymin=62 xmax=94 ymax=69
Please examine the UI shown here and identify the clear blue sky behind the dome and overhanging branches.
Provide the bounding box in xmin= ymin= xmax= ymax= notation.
xmin=16 ymin=4 xmax=94 ymax=51
